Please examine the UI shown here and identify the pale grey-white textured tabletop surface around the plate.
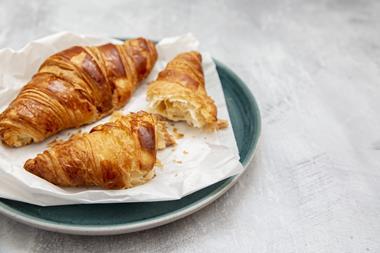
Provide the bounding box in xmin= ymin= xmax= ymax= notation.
xmin=0 ymin=0 xmax=380 ymax=252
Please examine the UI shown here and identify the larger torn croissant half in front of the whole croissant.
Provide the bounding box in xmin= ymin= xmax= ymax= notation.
xmin=24 ymin=111 xmax=175 ymax=189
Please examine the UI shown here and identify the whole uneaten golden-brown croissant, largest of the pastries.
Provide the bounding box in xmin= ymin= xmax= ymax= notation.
xmin=0 ymin=38 xmax=157 ymax=147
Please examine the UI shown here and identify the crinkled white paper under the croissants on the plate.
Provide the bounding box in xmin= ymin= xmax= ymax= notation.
xmin=0 ymin=32 xmax=243 ymax=206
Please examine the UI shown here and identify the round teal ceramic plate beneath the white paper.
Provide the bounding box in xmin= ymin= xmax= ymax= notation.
xmin=0 ymin=61 xmax=261 ymax=235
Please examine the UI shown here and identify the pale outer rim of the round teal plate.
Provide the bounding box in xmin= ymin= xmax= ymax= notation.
xmin=0 ymin=58 xmax=261 ymax=235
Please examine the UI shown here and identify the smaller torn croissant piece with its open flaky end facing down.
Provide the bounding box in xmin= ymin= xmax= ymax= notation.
xmin=147 ymin=51 xmax=228 ymax=129
